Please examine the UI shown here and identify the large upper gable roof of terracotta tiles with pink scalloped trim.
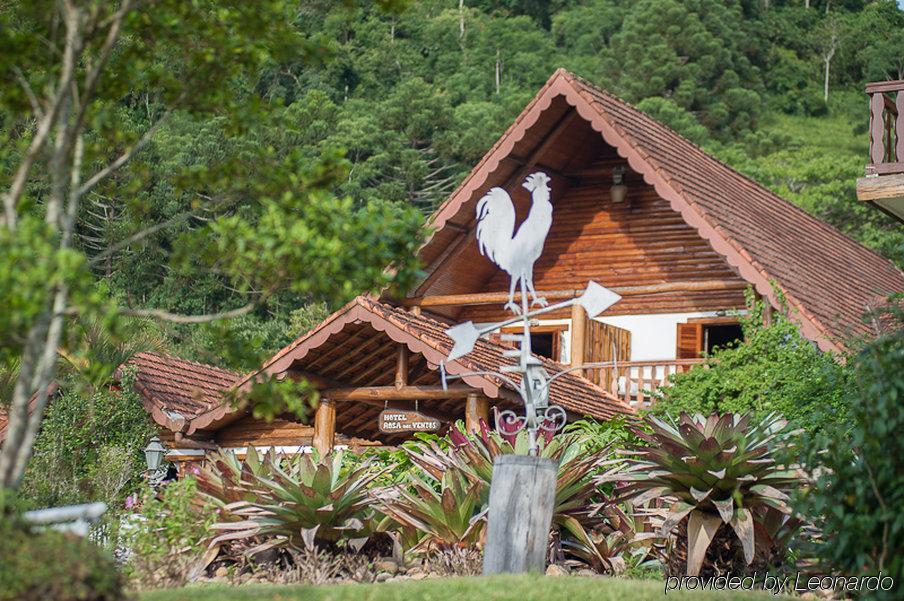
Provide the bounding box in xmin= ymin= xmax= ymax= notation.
xmin=421 ymin=69 xmax=904 ymax=350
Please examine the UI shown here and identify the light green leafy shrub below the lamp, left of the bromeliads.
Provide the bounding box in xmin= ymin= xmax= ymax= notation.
xmin=121 ymin=477 xmax=215 ymax=587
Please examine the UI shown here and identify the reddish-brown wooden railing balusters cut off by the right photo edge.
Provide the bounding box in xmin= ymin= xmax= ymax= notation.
xmin=866 ymin=80 xmax=904 ymax=175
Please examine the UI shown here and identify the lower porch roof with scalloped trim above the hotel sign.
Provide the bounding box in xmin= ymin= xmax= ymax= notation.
xmin=196 ymin=296 xmax=635 ymax=434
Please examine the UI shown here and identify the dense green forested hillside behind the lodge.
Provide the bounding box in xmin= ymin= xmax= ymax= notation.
xmin=7 ymin=0 xmax=904 ymax=368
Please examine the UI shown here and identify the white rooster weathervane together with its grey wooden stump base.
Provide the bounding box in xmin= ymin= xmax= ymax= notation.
xmin=440 ymin=172 xmax=621 ymax=574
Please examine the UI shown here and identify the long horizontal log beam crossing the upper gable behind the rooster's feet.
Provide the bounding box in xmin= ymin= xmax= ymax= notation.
xmin=404 ymin=280 xmax=749 ymax=307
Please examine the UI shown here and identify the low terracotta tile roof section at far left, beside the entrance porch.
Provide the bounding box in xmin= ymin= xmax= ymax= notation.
xmin=124 ymin=353 xmax=242 ymax=429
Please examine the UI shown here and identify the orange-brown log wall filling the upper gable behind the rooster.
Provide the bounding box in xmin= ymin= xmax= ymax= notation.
xmin=461 ymin=158 xmax=744 ymax=321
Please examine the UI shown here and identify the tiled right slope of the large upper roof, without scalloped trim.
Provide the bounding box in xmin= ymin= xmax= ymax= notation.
xmin=564 ymin=74 xmax=904 ymax=346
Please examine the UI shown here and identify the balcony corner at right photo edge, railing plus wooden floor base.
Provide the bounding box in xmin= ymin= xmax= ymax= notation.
xmin=857 ymin=80 xmax=904 ymax=222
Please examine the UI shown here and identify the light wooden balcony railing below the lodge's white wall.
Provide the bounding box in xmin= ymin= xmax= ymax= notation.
xmin=584 ymin=359 xmax=704 ymax=407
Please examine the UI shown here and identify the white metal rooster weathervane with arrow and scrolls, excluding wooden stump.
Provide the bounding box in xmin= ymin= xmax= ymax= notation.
xmin=440 ymin=171 xmax=621 ymax=455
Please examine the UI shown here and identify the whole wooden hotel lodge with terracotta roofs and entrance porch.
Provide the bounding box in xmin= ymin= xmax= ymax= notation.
xmin=0 ymin=70 xmax=904 ymax=472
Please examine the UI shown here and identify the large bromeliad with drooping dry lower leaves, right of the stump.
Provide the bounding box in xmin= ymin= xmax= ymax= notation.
xmin=616 ymin=413 xmax=800 ymax=576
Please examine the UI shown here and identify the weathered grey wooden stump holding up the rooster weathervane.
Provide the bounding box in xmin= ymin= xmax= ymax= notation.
xmin=483 ymin=455 xmax=557 ymax=575
